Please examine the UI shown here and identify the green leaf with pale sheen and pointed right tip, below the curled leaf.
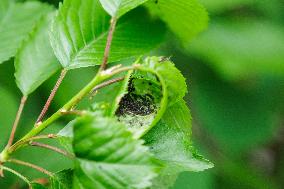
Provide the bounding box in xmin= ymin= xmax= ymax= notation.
xmin=143 ymin=100 xmax=213 ymax=188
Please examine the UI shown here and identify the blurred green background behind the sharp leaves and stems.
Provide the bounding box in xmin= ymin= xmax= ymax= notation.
xmin=0 ymin=0 xmax=284 ymax=189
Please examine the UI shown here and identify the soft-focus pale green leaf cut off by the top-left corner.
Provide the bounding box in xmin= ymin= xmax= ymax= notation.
xmin=0 ymin=0 xmax=52 ymax=64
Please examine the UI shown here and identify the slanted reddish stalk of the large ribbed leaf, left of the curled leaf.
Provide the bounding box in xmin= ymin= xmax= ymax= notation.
xmin=35 ymin=69 xmax=67 ymax=126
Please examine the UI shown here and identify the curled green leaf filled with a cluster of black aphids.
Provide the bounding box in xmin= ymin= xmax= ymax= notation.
xmin=113 ymin=57 xmax=187 ymax=138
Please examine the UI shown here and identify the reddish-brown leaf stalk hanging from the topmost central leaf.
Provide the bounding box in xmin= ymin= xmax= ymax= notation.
xmin=100 ymin=17 xmax=117 ymax=70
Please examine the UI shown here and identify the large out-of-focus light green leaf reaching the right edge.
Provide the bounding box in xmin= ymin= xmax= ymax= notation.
xmin=188 ymin=19 xmax=284 ymax=80
